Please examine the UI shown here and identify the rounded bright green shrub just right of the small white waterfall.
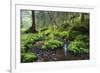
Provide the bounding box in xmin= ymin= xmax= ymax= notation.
xmin=68 ymin=40 xmax=89 ymax=54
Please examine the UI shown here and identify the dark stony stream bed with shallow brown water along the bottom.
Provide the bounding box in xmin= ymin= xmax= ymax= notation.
xmin=29 ymin=48 xmax=89 ymax=62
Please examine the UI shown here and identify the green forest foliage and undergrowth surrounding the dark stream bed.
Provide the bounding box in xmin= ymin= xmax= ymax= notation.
xmin=21 ymin=10 xmax=89 ymax=62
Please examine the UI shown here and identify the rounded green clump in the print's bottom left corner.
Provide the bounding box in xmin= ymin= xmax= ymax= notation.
xmin=21 ymin=52 xmax=37 ymax=63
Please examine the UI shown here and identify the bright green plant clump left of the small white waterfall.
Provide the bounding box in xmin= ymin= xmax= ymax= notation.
xmin=41 ymin=39 xmax=63 ymax=49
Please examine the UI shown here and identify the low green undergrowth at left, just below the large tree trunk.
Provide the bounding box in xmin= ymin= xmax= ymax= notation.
xmin=21 ymin=33 xmax=43 ymax=52
